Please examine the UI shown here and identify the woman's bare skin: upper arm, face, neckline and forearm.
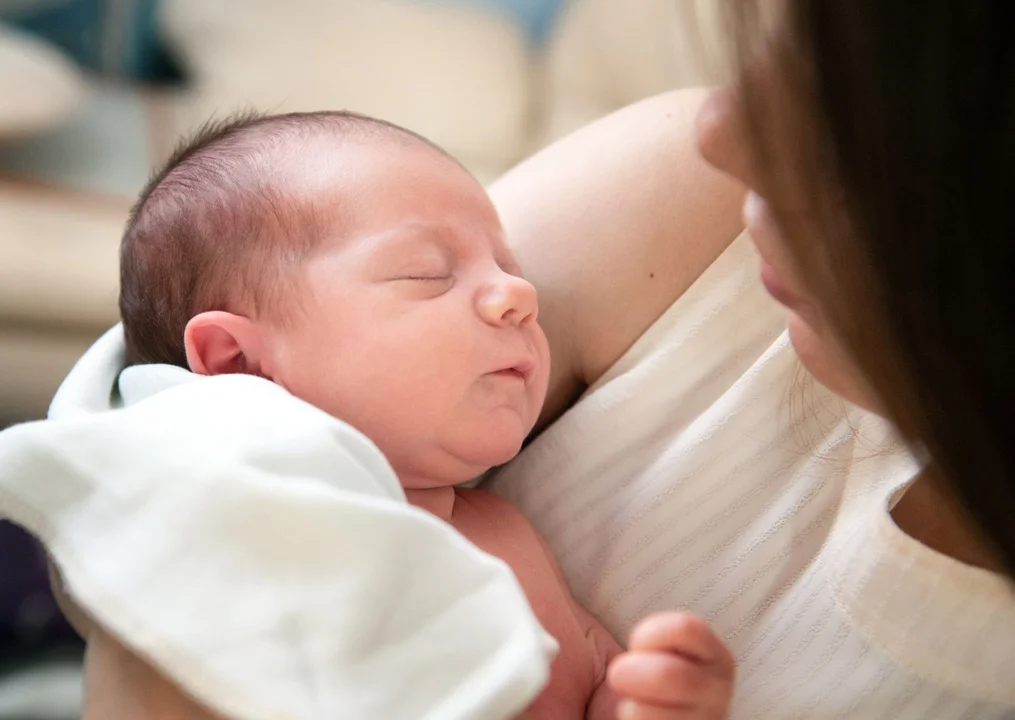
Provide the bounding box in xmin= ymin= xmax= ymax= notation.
xmin=63 ymin=71 xmax=997 ymax=720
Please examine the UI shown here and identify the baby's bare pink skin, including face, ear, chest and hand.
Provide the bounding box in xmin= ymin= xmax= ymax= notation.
xmin=186 ymin=136 xmax=733 ymax=720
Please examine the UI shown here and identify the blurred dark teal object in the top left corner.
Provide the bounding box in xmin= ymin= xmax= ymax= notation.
xmin=0 ymin=0 xmax=177 ymax=81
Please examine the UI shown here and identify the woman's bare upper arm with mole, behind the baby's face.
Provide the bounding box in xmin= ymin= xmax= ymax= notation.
xmin=490 ymin=90 xmax=743 ymax=427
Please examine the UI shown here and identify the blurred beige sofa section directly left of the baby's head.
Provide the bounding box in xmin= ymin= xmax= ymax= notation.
xmin=0 ymin=180 xmax=128 ymax=423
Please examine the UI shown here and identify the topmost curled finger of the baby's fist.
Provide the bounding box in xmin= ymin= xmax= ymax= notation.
xmin=627 ymin=612 xmax=736 ymax=679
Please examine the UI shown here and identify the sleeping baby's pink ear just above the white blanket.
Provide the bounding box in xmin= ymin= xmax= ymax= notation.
xmin=184 ymin=310 xmax=264 ymax=376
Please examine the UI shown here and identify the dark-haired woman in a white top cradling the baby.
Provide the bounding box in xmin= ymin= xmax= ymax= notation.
xmin=41 ymin=0 xmax=1015 ymax=718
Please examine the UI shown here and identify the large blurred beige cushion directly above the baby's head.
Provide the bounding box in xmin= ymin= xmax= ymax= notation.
xmin=162 ymin=0 xmax=531 ymax=176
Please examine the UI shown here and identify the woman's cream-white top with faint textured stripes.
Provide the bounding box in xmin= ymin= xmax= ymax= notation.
xmin=490 ymin=233 xmax=1015 ymax=720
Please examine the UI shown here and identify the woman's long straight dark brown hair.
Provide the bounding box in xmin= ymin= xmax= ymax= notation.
xmin=735 ymin=0 xmax=1015 ymax=572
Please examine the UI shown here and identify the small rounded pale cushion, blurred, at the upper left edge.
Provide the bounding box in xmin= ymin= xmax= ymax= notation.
xmin=0 ymin=23 xmax=84 ymax=138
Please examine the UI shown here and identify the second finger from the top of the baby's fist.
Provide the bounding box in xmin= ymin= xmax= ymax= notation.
xmin=607 ymin=652 xmax=732 ymax=710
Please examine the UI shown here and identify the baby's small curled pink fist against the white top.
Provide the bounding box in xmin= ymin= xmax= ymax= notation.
xmin=607 ymin=612 xmax=736 ymax=720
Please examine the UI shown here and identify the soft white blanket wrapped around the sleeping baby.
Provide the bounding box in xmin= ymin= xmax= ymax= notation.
xmin=0 ymin=328 xmax=556 ymax=720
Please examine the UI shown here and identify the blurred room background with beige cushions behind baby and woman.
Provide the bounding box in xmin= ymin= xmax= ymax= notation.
xmin=0 ymin=0 xmax=722 ymax=720
